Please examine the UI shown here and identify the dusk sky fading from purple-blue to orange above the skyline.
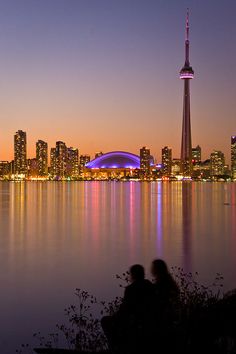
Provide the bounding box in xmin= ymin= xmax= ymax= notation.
xmin=0 ymin=0 xmax=236 ymax=160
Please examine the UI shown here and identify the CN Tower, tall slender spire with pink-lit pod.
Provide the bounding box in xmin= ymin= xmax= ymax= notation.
xmin=180 ymin=10 xmax=194 ymax=177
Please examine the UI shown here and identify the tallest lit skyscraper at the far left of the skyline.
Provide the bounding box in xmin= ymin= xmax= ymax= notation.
xmin=14 ymin=130 xmax=27 ymax=176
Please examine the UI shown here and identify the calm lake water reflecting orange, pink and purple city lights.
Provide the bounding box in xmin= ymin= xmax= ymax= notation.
xmin=0 ymin=182 xmax=236 ymax=354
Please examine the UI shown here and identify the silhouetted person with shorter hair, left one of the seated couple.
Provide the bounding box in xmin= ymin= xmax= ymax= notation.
xmin=101 ymin=264 xmax=154 ymax=352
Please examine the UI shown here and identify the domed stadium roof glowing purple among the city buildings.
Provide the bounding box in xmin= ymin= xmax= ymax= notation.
xmin=86 ymin=151 xmax=140 ymax=168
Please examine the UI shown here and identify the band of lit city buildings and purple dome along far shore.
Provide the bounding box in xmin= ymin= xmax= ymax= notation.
xmin=0 ymin=130 xmax=236 ymax=181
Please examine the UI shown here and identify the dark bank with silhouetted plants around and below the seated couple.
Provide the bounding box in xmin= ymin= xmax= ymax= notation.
xmin=18 ymin=268 xmax=236 ymax=354
